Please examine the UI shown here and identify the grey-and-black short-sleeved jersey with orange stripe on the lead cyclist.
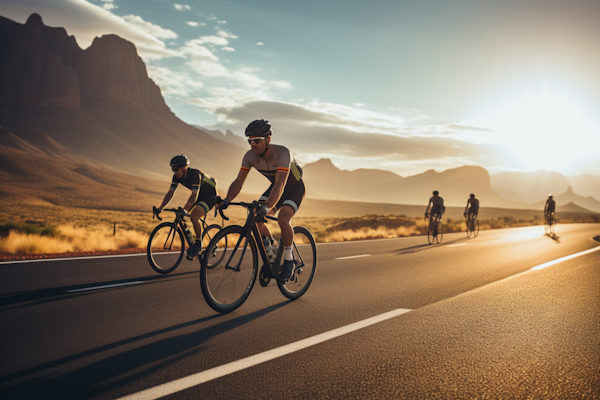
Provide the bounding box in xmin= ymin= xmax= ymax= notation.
xmin=241 ymin=144 xmax=302 ymax=188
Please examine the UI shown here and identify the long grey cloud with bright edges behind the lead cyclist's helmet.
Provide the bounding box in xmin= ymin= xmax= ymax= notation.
xmin=204 ymin=100 xmax=508 ymax=169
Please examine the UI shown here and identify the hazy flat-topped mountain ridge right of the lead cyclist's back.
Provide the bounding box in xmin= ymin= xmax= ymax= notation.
xmin=304 ymin=160 xmax=531 ymax=209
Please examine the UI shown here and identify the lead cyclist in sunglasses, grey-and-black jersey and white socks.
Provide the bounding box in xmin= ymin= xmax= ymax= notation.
xmin=219 ymin=119 xmax=305 ymax=280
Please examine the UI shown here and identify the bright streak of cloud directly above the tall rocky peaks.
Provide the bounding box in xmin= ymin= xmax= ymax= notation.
xmin=0 ymin=0 xmax=179 ymax=61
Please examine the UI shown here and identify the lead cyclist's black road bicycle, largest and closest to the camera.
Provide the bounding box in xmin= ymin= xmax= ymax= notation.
xmin=200 ymin=201 xmax=317 ymax=313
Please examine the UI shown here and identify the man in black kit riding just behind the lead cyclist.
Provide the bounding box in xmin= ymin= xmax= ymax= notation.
xmin=155 ymin=154 xmax=217 ymax=257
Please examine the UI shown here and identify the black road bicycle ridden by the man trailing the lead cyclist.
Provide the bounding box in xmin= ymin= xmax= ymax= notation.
xmin=146 ymin=207 xmax=222 ymax=274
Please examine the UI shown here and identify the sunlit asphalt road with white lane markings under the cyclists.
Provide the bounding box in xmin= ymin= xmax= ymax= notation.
xmin=0 ymin=224 xmax=600 ymax=399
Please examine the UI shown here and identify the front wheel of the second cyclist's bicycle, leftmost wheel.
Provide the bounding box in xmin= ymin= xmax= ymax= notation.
xmin=146 ymin=222 xmax=185 ymax=274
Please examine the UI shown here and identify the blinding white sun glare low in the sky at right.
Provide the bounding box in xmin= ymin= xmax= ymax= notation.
xmin=490 ymin=89 xmax=600 ymax=170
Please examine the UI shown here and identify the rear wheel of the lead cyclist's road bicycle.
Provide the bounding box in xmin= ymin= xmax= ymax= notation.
xmin=277 ymin=226 xmax=317 ymax=300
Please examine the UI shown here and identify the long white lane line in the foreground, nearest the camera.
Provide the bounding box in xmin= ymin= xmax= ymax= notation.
xmin=120 ymin=308 xmax=411 ymax=400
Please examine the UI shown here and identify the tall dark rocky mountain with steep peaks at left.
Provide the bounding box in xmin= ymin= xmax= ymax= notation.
xmin=0 ymin=14 xmax=264 ymax=189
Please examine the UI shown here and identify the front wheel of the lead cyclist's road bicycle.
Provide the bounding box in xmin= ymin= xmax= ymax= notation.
xmin=200 ymin=226 xmax=258 ymax=313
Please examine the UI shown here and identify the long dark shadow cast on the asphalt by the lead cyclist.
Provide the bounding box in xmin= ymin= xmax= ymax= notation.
xmin=0 ymin=300 xmax=291 ymax=399
